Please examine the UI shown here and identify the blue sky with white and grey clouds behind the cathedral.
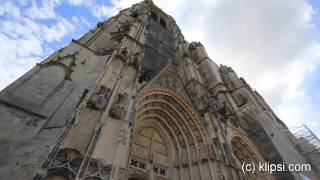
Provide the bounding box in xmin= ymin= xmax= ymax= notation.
xmin=0 ymin=0 xmax=320 ymax=136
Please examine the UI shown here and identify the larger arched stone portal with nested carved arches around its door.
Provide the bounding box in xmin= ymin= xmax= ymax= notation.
xmin=128 ymin=85 xmax=213 ymax=180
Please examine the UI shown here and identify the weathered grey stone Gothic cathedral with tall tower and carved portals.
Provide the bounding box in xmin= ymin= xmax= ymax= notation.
xmin=0 ymin=0 xmax=318 ymax=180
